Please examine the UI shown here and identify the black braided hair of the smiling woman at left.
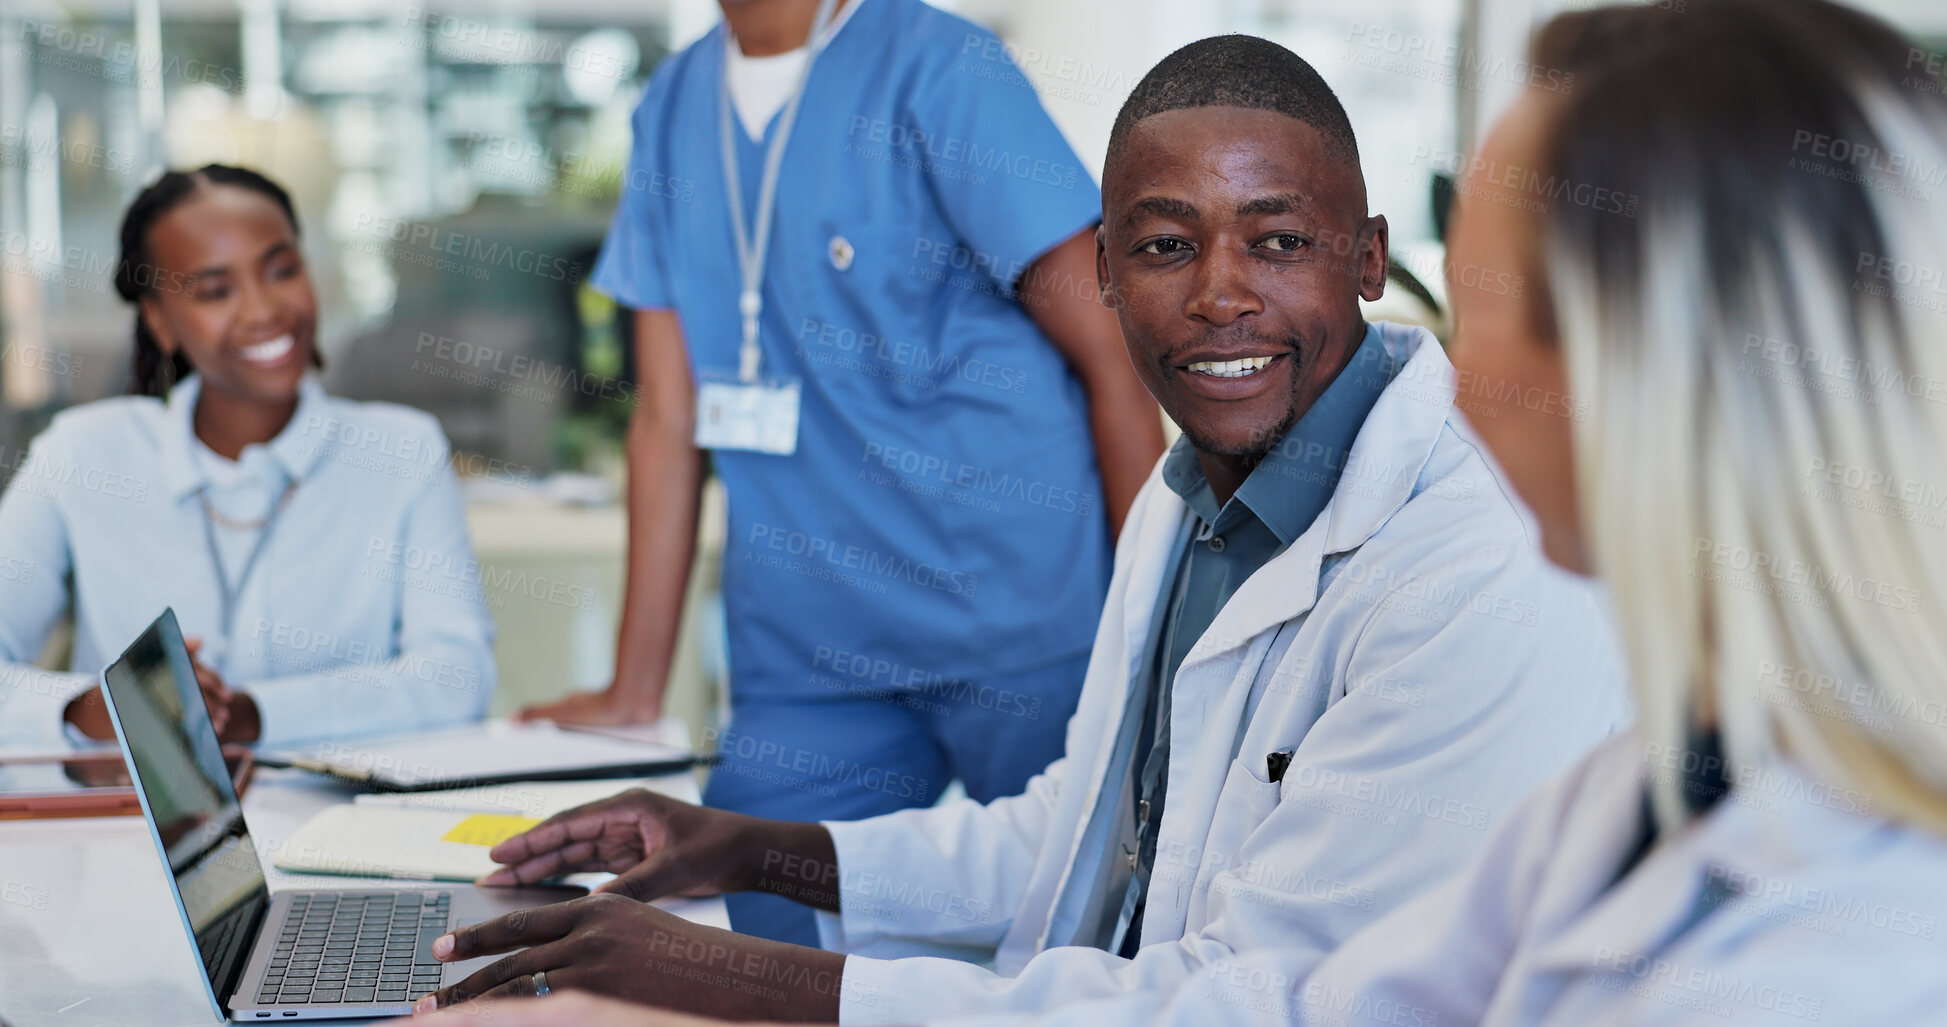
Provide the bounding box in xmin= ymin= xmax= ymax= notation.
xmin=115 ymin=164 xmax=315 ymax=396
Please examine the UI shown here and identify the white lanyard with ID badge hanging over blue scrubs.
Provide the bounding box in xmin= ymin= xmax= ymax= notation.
xmin=695 ymin=0 xmax=837 ymax=456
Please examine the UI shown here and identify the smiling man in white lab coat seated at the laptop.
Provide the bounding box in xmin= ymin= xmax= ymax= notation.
xmin=410 ymin=37 xmax=1628 ymax=1023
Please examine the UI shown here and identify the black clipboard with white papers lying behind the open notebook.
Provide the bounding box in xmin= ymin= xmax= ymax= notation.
xmin=257 ymin=721 xmax=709 ymax=791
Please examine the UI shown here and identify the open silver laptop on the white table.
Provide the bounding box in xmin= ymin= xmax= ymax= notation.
xmin=101 ymin=610 xmax=584 ymax=1021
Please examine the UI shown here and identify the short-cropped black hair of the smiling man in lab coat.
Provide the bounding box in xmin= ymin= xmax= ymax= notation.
xmin=1104 ymin=35 xmax=1359 ymax=171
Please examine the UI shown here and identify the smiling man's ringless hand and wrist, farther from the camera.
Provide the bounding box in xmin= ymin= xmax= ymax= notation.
xmin=479 ymin=789 xmax=839 ymax=910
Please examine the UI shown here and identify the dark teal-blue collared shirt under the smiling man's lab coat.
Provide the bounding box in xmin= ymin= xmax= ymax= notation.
xmin=1104 ymin=325 xmax=1398 ymax=955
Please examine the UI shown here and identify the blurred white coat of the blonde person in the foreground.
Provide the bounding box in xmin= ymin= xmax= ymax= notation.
xmin=1012 ymin=735 xmax=1947 ymax=1027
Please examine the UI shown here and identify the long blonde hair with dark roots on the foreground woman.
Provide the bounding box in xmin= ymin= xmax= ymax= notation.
xmin=1532 ymin=0 xmax=1947 ymax=834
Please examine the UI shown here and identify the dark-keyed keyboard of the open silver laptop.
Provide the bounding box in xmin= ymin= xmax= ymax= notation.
xmin=257 ymin=891 xmax=454 ymax=1006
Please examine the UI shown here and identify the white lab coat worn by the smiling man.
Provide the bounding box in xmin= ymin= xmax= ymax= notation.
xmin=820 ymin=325 xmax=1628 ymax=1023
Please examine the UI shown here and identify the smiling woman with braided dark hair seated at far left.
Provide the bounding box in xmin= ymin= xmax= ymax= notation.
xmin=0 ymin=164 xmax=495 ymax=744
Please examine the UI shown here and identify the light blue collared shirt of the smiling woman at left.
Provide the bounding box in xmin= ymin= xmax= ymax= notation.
xmin=0 ymin=376 xmax=495 ymax=746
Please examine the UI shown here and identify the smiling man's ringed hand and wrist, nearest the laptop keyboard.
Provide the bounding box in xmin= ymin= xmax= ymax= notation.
xmin=415 ymin=893 xmax=845 ymax=1023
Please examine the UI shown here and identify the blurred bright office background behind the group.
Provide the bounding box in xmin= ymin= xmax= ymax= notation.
xmin=0 ymin=0 xmax=1947 ymax=731
